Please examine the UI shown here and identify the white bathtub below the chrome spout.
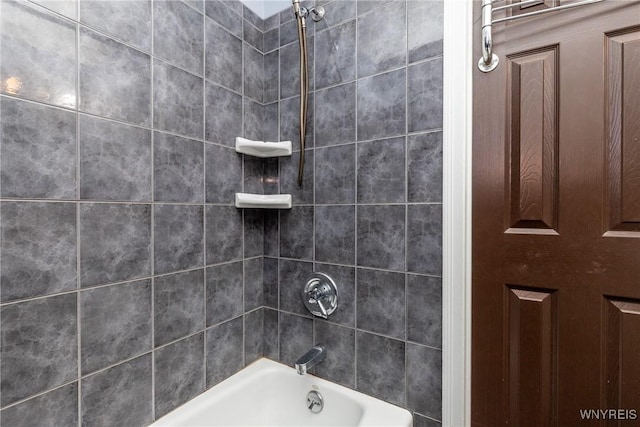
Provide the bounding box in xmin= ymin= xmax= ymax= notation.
xmin=151 ymin=359 xmax=412 ymax=427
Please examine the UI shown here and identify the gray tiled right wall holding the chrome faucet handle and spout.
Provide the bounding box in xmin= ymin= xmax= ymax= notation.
xmin=263 ymin=0 xmax=443 ymax=425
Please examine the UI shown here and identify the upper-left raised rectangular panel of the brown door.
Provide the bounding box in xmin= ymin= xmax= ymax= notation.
xmin=505 ymin=46 xmax=558 ymax=233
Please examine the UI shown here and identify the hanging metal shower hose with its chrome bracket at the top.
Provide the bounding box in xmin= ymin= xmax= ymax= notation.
xmin=292 ymin=0 xmax=324 ymax=186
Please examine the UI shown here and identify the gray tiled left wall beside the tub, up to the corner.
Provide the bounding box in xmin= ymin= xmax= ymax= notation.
xmin=0 ymin=0 xmax=272 ymax=427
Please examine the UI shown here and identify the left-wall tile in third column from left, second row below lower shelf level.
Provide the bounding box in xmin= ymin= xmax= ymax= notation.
xmin=153 ymin=270 xmax=205 ymax=347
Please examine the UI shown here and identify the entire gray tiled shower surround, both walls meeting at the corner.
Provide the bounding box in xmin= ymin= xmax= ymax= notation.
xmin=0 ymin=0 xmax=442 ymax=426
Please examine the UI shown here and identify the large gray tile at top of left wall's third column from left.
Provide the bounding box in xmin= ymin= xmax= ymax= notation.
xmin=153 ymin=1 xmax=204 ymax=75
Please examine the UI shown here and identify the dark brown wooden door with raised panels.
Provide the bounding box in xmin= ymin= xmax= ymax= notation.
xmin=471 ymin=0 xmax=640 ymax=427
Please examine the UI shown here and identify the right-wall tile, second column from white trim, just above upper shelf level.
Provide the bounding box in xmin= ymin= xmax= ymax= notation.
xmin=357 ymin=69 xmax=406 ymax=141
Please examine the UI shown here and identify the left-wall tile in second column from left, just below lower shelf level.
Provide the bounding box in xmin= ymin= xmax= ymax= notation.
xmin=80 ymin=203 xmax=151 ymax=287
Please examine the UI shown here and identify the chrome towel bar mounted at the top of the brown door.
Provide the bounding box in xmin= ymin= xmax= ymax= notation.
xmin=478 ymin=0 xmax=604 ymax=73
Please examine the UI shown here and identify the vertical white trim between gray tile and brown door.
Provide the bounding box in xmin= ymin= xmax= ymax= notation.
xmin=442 ymin=0 xmax=473 ymax=427
